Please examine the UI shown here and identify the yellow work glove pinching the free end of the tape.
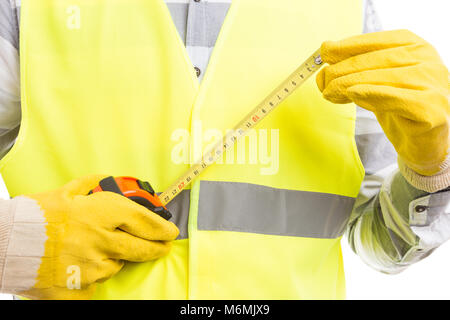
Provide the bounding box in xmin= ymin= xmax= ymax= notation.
xmin=317 ymin=30 xmax=450 ymax=176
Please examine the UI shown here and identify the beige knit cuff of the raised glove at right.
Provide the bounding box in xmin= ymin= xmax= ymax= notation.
xmin=398 ymin=157 xmax=450 ymax=193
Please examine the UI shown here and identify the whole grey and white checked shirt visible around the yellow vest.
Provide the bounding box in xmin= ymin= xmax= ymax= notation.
xmin=0 ymin=0 xmax=450 ymax=273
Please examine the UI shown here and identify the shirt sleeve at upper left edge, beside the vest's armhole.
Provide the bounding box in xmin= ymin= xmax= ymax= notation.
xmin=0 ymin=0 xmax=21 ymax=158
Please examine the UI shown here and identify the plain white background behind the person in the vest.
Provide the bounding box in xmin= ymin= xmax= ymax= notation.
xmin=0 ymin=0 xmax=450 ymax=300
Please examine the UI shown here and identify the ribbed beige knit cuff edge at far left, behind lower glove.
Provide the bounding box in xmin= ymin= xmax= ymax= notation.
xmin=0 ymin=199 xmax=14 ymax=292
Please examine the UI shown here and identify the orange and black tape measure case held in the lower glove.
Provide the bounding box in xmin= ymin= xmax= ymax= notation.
xmin=89 ymin=177 xmax=172 ymax=220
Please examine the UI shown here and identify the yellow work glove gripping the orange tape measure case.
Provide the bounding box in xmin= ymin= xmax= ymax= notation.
xmin=20 ymin=176 xmax=178 ymax=299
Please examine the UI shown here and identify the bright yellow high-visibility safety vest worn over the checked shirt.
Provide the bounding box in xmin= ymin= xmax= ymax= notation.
xmin=0 ymin=0 xmax=364 ymax=299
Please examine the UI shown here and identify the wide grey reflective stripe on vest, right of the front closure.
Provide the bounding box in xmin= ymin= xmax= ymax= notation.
xmin=198 ymin=181 xmax=355 ymax=239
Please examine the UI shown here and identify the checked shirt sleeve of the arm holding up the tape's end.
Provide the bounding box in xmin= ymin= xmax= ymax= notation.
xmin=347 ymin=0 xmax=450 ymax=274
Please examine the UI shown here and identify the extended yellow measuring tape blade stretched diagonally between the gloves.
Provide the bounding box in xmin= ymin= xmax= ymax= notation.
xmin=159 ymin=50 xmax=323 ymax=205
